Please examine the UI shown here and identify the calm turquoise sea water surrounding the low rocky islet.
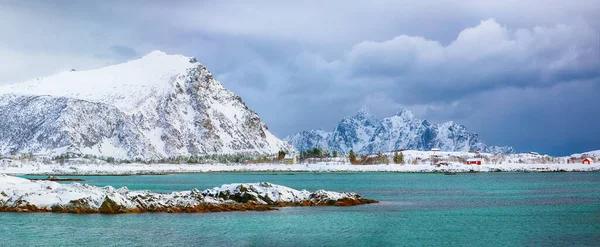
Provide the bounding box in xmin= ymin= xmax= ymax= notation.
xmin=0 ymin=173 xmax=600 ymax=246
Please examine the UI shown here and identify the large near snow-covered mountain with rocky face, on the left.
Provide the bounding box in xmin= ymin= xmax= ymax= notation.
xmin=0 ymin=51 xmax=293 ymax=159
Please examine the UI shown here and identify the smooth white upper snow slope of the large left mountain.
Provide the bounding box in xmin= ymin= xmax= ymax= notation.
xmin=1 ymin=51 xmax=194 ymax=112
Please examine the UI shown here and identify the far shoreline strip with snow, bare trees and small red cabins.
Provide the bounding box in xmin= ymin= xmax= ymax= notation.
xmin=0 ymin=149 xmax=600 ymax=176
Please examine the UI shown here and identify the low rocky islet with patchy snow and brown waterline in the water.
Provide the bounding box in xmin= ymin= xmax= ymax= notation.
xmin=0 ymin=174 xmax=377 ymax=214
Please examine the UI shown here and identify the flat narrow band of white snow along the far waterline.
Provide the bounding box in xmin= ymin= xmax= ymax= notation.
xmin=0 ymin=159 xmax=600 ymax=175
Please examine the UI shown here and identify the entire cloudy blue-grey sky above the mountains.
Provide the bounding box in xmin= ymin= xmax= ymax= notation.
xmin=0 ymin=0 xmax=600 ymax=155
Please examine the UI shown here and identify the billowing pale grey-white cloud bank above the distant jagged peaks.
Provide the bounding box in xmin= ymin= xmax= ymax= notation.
xmin=328 ymin=19 xmax=600 ymax=101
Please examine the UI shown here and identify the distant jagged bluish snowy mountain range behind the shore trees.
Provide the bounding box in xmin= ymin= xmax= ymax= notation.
xmin=284 ymin=107 xmax=514 ymax=153
